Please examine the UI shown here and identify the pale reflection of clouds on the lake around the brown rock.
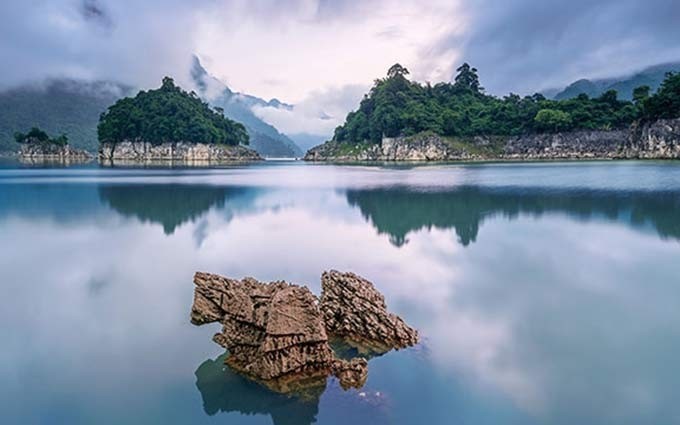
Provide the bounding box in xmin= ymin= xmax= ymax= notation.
xmin=0 ymin=181 xmax=680 ymax=423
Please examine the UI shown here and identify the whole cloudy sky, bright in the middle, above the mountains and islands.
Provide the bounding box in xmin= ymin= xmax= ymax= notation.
xmin=0 ymin=0 xmax=680 ymax=133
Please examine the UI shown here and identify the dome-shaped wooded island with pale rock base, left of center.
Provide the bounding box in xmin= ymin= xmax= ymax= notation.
xmin=97 ymin=77 xmax=262 ymax=165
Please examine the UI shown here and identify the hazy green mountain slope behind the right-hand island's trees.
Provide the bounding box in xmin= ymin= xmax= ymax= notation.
xmin=553 ymin=62 xmax=680 ymax=100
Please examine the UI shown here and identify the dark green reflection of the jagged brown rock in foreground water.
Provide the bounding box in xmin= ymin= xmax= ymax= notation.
xmin=196 ymin=354 xmax=325 ymax=425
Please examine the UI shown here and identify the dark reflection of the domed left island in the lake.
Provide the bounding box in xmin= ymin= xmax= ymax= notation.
xmin=99 ymin=184 xmax=247 ymax=235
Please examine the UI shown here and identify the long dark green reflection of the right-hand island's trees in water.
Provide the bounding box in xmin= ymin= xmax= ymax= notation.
xmin=347 ymin=187 xmax=680 ymax=246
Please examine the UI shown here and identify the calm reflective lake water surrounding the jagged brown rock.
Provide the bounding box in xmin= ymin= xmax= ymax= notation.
xmin=0 ymin=162 xmax=680 ymax=425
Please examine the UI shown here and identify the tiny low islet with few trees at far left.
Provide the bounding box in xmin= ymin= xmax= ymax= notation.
xmin=14 ymin=127 xmax=92 ymax=163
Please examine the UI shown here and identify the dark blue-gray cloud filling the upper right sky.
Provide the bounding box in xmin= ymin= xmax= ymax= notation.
xmin=444 ymin=0 xmax=680 ymax=94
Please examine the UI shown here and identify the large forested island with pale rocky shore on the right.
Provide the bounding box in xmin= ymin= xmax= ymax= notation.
xmin=305 ymin=64 xmax=680 ymax=161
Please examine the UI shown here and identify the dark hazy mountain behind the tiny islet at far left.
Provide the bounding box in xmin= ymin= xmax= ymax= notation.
xmin=0 ymin=79 xmax=131 ymax=152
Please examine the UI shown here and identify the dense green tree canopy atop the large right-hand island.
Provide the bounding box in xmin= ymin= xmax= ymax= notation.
xmin=333 ymin=63 xmax=680 ymax=143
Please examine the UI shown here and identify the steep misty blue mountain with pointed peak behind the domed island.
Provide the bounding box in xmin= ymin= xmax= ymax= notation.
xmin=191 ymin=56 xmax=303 ymax=157
